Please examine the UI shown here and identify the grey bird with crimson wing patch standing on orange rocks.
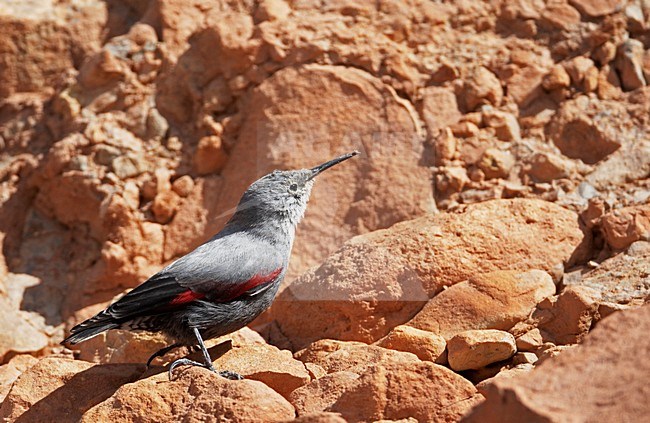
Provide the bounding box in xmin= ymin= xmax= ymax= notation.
xmin=62 ymin=151 xmax=359 ymax=380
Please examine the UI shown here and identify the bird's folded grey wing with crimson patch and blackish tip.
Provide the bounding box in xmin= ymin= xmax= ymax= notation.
xmin=106 ymin=234 xmax=286 ymax=319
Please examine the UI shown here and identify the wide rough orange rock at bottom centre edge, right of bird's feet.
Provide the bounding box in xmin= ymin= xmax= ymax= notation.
xmin=291 ymin=361 xmax=477 ymax=422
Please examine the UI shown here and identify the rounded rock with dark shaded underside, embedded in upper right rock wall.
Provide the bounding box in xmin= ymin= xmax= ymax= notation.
xmin=549 ymin=97 xmax=629 ymax=164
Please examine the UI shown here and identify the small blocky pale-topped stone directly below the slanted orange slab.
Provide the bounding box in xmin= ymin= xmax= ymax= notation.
xmin=447 ymin=330 xmax=517 ymax=371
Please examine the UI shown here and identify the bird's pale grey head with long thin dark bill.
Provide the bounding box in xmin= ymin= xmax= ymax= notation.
xmin=236 ymin=151 xmax=359 ymax=225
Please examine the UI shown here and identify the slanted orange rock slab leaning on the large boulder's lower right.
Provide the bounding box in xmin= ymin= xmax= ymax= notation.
xmin=408 ymin=270 xmax=555 ymax=340
